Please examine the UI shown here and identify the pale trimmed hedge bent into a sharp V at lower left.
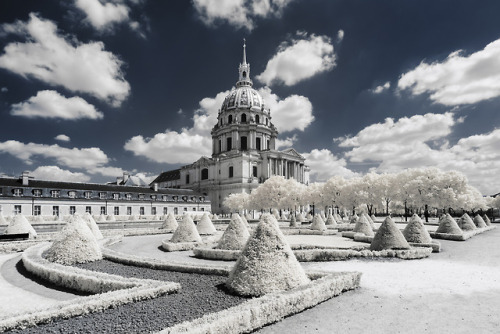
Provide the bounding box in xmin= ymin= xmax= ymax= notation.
xmin=0 ymin=243 xmax=181 ymax=332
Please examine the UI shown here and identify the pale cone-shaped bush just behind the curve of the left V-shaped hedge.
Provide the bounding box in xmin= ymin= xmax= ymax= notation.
xmin=45 ymin=216 xmax=102 ymax=265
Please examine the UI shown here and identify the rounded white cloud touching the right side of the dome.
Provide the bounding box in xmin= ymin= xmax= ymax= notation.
xmin=258 ymin=87 xmax=314 ymax=133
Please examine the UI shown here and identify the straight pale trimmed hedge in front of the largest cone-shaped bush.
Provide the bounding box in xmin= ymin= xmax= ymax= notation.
xmin=159 ymin=272 xmax=361 ymax=334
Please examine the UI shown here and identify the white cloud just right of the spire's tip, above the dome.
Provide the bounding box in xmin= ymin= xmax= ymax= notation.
xmin=256 ymin=32 xmax=336 ymax=86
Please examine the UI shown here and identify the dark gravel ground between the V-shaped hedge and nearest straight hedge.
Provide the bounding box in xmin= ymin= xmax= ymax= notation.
xmin=14 ymin=260 xmax=250 ymax=333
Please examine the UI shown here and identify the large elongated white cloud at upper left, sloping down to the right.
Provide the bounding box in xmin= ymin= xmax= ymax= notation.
xmin=0 ymin=13 xmax=130 ymax=107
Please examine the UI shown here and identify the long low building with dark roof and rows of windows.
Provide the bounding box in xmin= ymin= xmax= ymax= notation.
xmin=0 ymin=172 xmax=210 ymax=217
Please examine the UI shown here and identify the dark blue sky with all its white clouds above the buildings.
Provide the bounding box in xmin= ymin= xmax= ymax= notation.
xmin=0 ymin=0 xmax=500 ymax=195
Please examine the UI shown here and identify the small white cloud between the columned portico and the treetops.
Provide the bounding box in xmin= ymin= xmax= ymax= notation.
xmin=301 ymin=149 xmax=357 ymax=182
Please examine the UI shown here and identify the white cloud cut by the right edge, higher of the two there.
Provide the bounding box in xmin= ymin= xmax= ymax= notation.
xmin=398 ymin=39 xmax=500 ymax=106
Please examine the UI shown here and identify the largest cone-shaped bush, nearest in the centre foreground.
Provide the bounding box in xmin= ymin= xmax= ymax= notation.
xmin=226 ymin=214 xmax=309 ymax=296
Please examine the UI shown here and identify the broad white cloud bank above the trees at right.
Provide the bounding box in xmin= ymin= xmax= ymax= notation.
xmin=337 ymin=113 xmax=500 ymax=194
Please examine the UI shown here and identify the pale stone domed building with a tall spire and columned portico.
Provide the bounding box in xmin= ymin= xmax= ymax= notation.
xmin=152 ymin=44 xmax=309 ymax=213
